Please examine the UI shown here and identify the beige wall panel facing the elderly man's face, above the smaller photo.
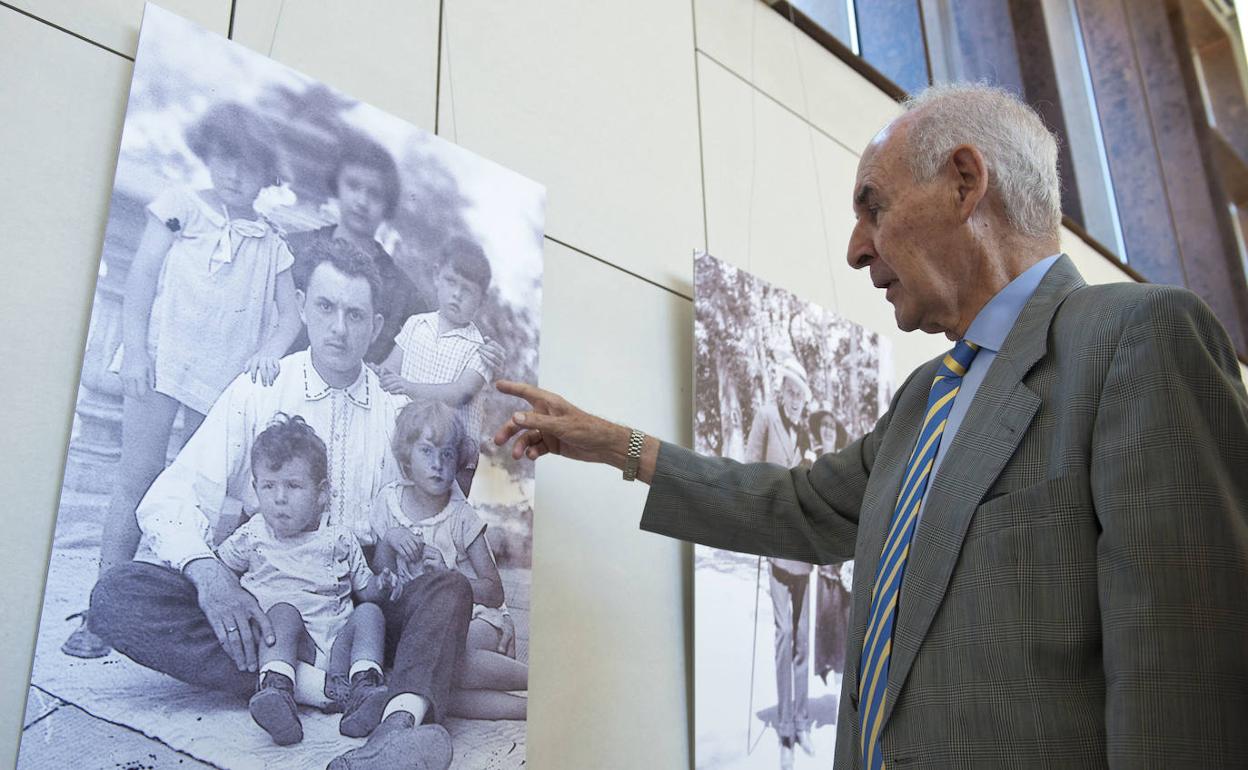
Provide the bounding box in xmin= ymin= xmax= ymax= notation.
xmin=699 ymin=52 xmax=948 ymax=382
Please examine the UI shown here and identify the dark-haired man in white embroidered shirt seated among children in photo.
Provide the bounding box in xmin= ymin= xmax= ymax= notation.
xmin=89 ymin=240 xmax=472 ymax=769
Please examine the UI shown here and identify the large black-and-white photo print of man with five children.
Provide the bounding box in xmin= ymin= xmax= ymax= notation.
xmin=17 ymin=4 xmax=545 ymax=769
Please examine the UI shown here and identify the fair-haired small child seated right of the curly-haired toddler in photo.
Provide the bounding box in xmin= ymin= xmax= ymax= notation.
xmin=372 ymin=401 xmax=528 ymax=719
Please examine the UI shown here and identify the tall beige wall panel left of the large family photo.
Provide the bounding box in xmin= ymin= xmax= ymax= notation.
xmin=0 ymin=9 xmax=131 ymax=768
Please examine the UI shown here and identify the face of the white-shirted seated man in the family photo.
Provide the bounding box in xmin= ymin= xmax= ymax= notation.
xmin=300 ymin=262 xmax=382 ymax=376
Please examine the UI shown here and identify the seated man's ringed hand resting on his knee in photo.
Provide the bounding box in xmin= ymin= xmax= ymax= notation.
xmin=185 ymin=559 xmax=277 ymax=671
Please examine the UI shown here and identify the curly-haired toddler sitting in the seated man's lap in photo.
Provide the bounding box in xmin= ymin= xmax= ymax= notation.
xmin=217 ymin=414 xmax=399 ymax=745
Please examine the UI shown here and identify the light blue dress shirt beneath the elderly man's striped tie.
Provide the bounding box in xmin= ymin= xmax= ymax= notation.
xmin=919 ymin=255 xmax=1062 ymax=520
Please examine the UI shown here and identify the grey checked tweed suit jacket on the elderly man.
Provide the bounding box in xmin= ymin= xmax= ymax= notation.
xmin=641 ymin=257 xmax=1248 ymax=770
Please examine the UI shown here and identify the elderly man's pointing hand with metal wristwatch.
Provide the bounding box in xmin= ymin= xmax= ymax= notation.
xmin=494 ymin=379 xmax=659 ymax=482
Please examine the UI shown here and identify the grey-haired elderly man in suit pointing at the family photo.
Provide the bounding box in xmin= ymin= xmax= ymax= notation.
xmin=495 ymin=86 xmax=1248 ymax=769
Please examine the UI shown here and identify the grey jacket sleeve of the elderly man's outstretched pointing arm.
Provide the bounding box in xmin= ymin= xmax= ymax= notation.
xmin=641 ymin=374 xmax=914 ymax=564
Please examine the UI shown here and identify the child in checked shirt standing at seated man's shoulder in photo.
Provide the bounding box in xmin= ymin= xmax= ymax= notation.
xmin=379 ymin=237 xmax=503 ymax=497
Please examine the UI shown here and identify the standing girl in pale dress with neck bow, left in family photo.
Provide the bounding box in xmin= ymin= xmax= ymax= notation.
xmin=61 ymin=104 xmax=302 ymax=658
